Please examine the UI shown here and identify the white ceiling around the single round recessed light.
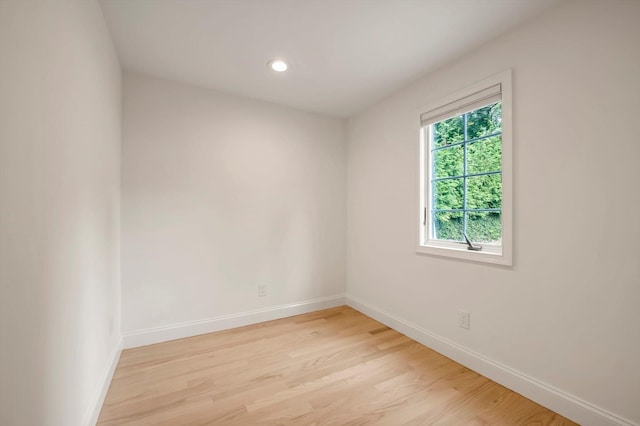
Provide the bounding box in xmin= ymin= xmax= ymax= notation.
xmin=101 ymin=0 xmax=557 ymax=117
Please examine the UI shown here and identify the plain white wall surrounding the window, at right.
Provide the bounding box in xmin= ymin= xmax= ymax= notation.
xmin=347 ymin=1 xmax=640 ymax=422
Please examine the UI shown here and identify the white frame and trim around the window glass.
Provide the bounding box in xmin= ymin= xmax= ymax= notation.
xmin=416 ymin=70 xmax=513 ymax=266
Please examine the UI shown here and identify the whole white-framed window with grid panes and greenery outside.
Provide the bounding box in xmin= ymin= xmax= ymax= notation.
xmin=417 ymin=71 xmax=512 ymax=265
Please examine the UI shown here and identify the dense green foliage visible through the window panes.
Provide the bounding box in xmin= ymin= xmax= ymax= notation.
xmin=432 ymin=102 xmax=502 ymax=242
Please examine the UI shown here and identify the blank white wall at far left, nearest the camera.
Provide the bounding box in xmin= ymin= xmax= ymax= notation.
xmin=0 ymin=1 xmax=121 ymax=426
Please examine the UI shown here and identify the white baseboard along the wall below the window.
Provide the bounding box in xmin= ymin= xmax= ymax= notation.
xmin=346 ymin=294 xmax=639 ymax=426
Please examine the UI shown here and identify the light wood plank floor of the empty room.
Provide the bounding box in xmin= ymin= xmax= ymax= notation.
xmin=98 ymin=307 xmax=574 ymax=426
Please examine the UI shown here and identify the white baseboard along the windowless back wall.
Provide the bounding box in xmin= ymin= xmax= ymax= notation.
xmin=124 ymin=294 xmax=344 ymax=349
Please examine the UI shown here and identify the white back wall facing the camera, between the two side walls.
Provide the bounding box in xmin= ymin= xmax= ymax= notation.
xmin=122 ymin=73 xmax=346 ymax=338
